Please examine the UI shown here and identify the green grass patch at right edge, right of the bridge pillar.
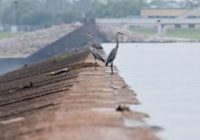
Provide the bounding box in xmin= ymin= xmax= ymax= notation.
xmin=166 ymin=28 xmax=200 ymax=40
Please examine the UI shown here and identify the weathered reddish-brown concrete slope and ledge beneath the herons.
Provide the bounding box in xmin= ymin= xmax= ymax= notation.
xmin=0 ymin=51 xmax=157 ymax=140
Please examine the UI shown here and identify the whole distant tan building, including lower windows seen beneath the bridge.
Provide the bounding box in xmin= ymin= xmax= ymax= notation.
xmin=141 ymin=8 xmax=200 ymax=28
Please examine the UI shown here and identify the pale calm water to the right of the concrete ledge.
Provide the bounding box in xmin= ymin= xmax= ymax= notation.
xmin=103 ymin=43 xmax=200 ymax=140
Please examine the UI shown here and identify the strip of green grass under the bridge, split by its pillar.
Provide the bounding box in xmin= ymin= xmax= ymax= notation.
xmin=131 ymin=28 xmax=200 ymax=40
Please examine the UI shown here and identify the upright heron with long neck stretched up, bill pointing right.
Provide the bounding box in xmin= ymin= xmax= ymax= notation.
xmin=106 ymin=32 xmax=125 ymax=74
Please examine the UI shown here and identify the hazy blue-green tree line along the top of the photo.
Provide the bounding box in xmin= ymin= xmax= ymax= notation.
xmin=0 ymin=0 xmax=199 ymax=26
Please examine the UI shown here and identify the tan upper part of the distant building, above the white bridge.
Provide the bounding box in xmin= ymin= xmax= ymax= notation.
xmin=141 ymin=8 xmax=200 ymax=19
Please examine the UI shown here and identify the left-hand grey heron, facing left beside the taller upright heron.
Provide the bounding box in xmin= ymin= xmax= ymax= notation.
xmin=87 ymin=33 xmax=105 ymax=70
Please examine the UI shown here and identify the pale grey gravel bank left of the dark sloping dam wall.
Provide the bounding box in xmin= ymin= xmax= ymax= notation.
xmin=0 ymin=24 xmax=79 ymax=58
